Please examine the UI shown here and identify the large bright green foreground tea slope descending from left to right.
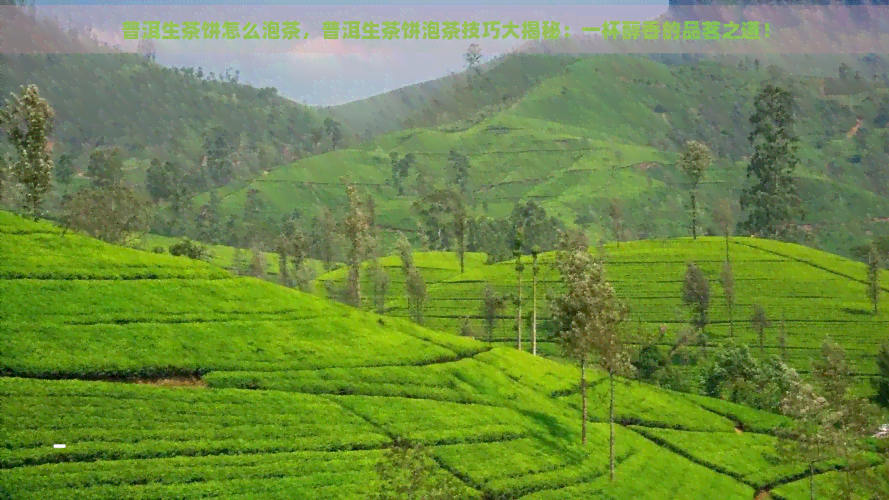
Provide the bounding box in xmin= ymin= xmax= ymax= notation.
xmin=0 ymin=210 xmax=864 ymax=500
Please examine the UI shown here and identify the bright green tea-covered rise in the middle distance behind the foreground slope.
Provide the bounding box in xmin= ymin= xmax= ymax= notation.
xmin=387 ymin=237 xmax=889 ymax=373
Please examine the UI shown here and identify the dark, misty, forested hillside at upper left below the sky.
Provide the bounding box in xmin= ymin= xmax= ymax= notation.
xmin=0 ymin=6 xmax=338 ymax=199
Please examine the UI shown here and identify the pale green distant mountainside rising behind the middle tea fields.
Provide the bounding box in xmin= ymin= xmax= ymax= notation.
xmin=206 ymin=56 xmax=889 ymax=258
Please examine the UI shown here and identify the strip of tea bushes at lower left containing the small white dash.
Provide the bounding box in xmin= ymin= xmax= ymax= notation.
xmin=0 ymin=378 xmax=388 ymax=468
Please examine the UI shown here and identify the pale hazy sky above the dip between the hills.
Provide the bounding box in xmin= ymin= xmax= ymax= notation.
xmin=24 ymin=0 xmax=667 ymax=105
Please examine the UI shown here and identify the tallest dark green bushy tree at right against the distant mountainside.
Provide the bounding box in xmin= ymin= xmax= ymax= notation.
xmin=741 ymin=84 xmax=803 ymax=239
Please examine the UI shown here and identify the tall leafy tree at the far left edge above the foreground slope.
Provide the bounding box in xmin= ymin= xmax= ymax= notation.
xmin=0 ymin=85 xmax=55 ymax=218
